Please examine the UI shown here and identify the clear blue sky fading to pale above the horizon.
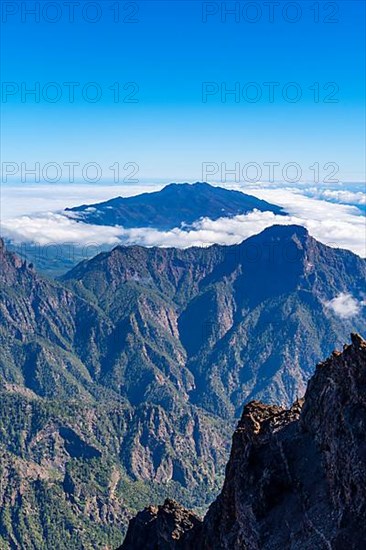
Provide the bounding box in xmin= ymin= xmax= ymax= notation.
xmin=2 ymin=0 xmax=365 ymax=181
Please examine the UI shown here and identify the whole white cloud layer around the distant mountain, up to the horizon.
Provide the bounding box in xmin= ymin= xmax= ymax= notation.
xmin=2 ymin=182 xmax=366 ymax=257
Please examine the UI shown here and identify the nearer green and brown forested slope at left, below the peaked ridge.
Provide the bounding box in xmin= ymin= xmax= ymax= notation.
xmin=0 ymin=239 xmax=227 ymax=550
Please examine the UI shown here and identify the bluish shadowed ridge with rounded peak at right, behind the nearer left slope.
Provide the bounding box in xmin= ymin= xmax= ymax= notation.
xmin=63 ymin=226 xmax=366 ymax=418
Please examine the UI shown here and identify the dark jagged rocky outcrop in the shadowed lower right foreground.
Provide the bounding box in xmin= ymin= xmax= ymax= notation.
xmin=120 ymin=334 xmax=366 ymax=550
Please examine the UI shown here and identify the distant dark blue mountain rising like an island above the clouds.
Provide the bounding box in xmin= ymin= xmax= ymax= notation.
xmin=66 ymin=183 xmax=285 ymax=230
